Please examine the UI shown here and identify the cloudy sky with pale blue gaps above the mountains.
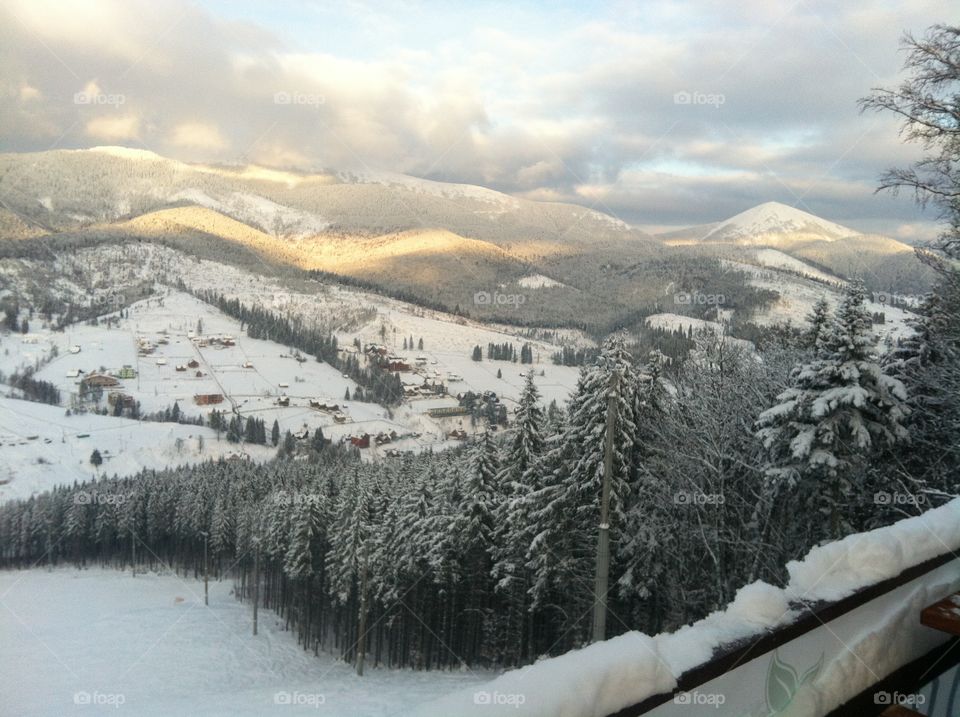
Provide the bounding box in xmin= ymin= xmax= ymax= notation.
xmin=0 ymin=0 xmax=955 ymax=240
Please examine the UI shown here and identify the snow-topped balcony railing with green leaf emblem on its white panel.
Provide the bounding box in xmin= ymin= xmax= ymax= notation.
xmin=416 ymin=499 xmax=960 ymax=717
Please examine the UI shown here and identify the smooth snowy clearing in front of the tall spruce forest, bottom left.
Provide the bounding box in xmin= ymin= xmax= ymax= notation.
xmin=0 ymin=568 xmax=494 ymax=717
